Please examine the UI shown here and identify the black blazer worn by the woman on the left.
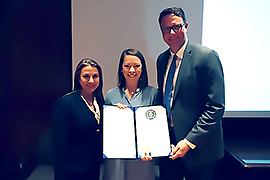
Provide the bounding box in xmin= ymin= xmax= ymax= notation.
xmin=52 ymin=91 xmax=103 ymax=180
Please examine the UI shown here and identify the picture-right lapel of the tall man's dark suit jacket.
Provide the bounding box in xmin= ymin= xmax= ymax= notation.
xmin=173 ymin=42 xmax=192 ymax=102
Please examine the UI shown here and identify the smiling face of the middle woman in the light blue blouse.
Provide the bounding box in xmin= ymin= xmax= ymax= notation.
xmin=122 ymin=55 xmax=142 ymax=82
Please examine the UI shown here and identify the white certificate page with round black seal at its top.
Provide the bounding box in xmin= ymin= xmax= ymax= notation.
xmin=135 ymin=106 xmax=171 ymax=157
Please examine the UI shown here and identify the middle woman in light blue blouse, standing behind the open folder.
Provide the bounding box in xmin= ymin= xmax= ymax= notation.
xmin=103 ymin=49 xmax=157 ymax=180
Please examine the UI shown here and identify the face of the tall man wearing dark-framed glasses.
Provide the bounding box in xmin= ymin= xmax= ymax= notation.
xmin=161 ymin=14 xmax=188 ymax=53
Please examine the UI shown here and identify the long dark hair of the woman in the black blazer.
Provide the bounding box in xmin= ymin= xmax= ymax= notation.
xmin=73 ymin=58 xmax=104 ymax=102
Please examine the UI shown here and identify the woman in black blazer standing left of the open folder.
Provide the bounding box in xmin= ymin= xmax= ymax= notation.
xmin=53 ymin=58 xmax=104 ymax=180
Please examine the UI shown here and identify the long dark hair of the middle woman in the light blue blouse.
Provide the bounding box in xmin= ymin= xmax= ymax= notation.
xmin=117 ymin=48 xmax=148 ymax=89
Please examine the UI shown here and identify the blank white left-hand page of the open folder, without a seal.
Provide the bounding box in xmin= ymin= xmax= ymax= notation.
xmin=103 ymin=105 xmax=136 ymax=158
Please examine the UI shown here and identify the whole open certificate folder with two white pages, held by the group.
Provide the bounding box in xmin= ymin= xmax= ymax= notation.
xmin=103 ymin=105 xmax=171 ymax=159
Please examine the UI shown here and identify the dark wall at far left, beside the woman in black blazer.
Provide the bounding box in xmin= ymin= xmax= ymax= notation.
xmin=0 ymin=0 xmax=72 ymax=179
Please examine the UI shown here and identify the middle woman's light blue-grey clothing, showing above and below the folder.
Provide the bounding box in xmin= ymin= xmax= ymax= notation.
xmin=103 ymin=86 xmax=157 ymax=180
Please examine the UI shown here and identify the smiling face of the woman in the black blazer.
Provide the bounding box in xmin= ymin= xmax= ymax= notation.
xmin=79 ymin=66 xmax=99 ymax=95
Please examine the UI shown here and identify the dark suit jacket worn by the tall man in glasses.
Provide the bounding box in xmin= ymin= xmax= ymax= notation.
xmin=157 ymin=42 xmax=225 ymax=167
